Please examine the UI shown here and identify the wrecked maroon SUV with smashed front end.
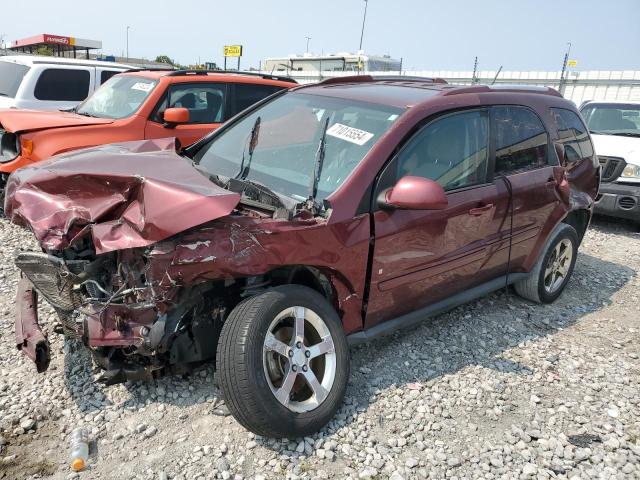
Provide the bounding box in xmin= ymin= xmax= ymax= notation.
xmin=5 ymin=76 xmax=599 ymax=437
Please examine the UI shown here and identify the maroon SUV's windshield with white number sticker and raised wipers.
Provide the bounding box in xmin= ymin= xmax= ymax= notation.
xmin=194 ymin=92 xmax=403 ymax=202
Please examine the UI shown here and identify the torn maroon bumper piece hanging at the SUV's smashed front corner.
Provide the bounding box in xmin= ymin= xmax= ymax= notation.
xmin=16 ymin=276 xmax=51 ymax=373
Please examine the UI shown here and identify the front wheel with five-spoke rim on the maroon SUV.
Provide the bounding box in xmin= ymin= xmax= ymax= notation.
xmin=216 ymin=285 xmax=349 ymax=438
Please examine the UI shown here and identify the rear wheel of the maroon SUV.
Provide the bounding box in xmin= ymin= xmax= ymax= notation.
xmin=513 ymin=223 xmax=580 ymax=303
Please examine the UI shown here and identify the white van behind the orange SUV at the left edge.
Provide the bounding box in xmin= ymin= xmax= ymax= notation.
xmin=0 ymin=55 xmax=132 ymax=110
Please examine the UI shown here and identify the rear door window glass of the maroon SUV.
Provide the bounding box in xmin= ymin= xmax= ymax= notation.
xmin=491 ymin=106 xmax=548 ymax=173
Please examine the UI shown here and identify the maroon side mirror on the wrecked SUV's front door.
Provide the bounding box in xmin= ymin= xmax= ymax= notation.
xmin=378 ymin=176 xmax=449 ymax=210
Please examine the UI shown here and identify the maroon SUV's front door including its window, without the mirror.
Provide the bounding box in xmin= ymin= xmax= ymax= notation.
xmin=365 ymin=109 xmax=505 ymax=328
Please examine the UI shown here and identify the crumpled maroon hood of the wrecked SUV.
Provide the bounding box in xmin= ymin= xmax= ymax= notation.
xmin=5 ymin=138 xmax=240 ymax=253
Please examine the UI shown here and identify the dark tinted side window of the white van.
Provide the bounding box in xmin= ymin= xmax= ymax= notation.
xmin=34 ymin=68 xmax=90 ymax=102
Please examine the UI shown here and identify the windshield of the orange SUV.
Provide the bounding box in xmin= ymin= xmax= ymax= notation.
xmin=76 ymin=75 xmax=156 ymax=118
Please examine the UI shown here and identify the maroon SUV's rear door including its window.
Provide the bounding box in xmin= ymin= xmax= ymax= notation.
xmin=484 ymin=105 xmax=563 ymax=274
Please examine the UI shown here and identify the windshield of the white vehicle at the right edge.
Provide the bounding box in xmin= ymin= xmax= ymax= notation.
xmin=580 ymin=103 xmax=640 ymax=136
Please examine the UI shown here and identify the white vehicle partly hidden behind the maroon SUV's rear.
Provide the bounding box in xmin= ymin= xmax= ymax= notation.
xmin=580 ymin=102 xmax=640 ymax=224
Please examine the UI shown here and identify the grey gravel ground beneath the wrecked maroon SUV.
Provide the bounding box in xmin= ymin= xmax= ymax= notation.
xmin=0 ymin=220 xmax=640 ymax=480
